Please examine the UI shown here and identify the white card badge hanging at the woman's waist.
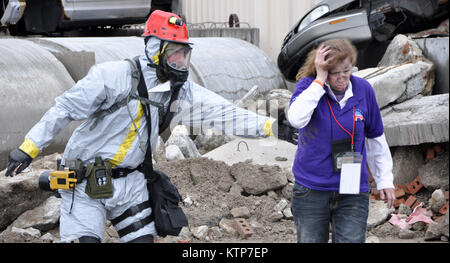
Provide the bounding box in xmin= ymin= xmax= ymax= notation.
xmin=338 ymin=152 xmax=363 ymax=194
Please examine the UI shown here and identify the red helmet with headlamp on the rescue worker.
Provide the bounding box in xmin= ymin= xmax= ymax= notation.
xmin=142 ymin=10 xmax=192 ymax=44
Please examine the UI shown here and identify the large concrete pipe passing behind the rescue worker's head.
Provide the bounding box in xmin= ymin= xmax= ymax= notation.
xmin=30 ymin=37 xmax=286 ymax=100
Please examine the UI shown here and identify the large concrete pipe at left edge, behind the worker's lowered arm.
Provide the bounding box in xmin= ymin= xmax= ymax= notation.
xmin=0 ymin=39 xmax=76 ymax=170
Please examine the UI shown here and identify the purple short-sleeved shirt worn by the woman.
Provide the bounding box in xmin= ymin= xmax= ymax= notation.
xmin=290 ymin=75 xmax=384 ymax=192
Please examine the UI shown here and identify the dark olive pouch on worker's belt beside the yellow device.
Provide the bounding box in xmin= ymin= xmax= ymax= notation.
xmin=85 ymin=157 xmax=114 ymax=199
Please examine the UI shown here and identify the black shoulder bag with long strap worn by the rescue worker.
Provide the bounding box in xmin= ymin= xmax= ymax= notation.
xmin=136 ymin=56 xmax=188 ymax=237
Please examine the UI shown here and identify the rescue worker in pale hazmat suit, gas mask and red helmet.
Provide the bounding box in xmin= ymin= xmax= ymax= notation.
xmin=6 ymin=10 xmax=297 ymax=243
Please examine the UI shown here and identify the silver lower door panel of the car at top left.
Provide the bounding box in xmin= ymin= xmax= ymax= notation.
xmin=63 ymin=0 xmax=151 ymax=21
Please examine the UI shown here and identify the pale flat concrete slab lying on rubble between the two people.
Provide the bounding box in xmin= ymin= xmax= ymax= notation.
xmin=203 ymin=137 xmax=297 ymax=169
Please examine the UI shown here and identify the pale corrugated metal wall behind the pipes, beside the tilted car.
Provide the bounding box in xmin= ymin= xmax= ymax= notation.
xmin=181 ymin=0 xmax=320 ymax=62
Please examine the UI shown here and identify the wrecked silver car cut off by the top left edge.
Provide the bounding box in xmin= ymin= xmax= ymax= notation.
xmin=0 ymin=0 xmax=178 ymax=35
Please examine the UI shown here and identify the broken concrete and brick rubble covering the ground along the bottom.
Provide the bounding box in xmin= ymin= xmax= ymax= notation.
xmin=0 ymin=146 xmax=448 ymax=243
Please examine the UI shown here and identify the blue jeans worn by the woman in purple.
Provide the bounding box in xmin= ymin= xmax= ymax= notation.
xmin=291 ymin=183 xmax=369 ymax=243
